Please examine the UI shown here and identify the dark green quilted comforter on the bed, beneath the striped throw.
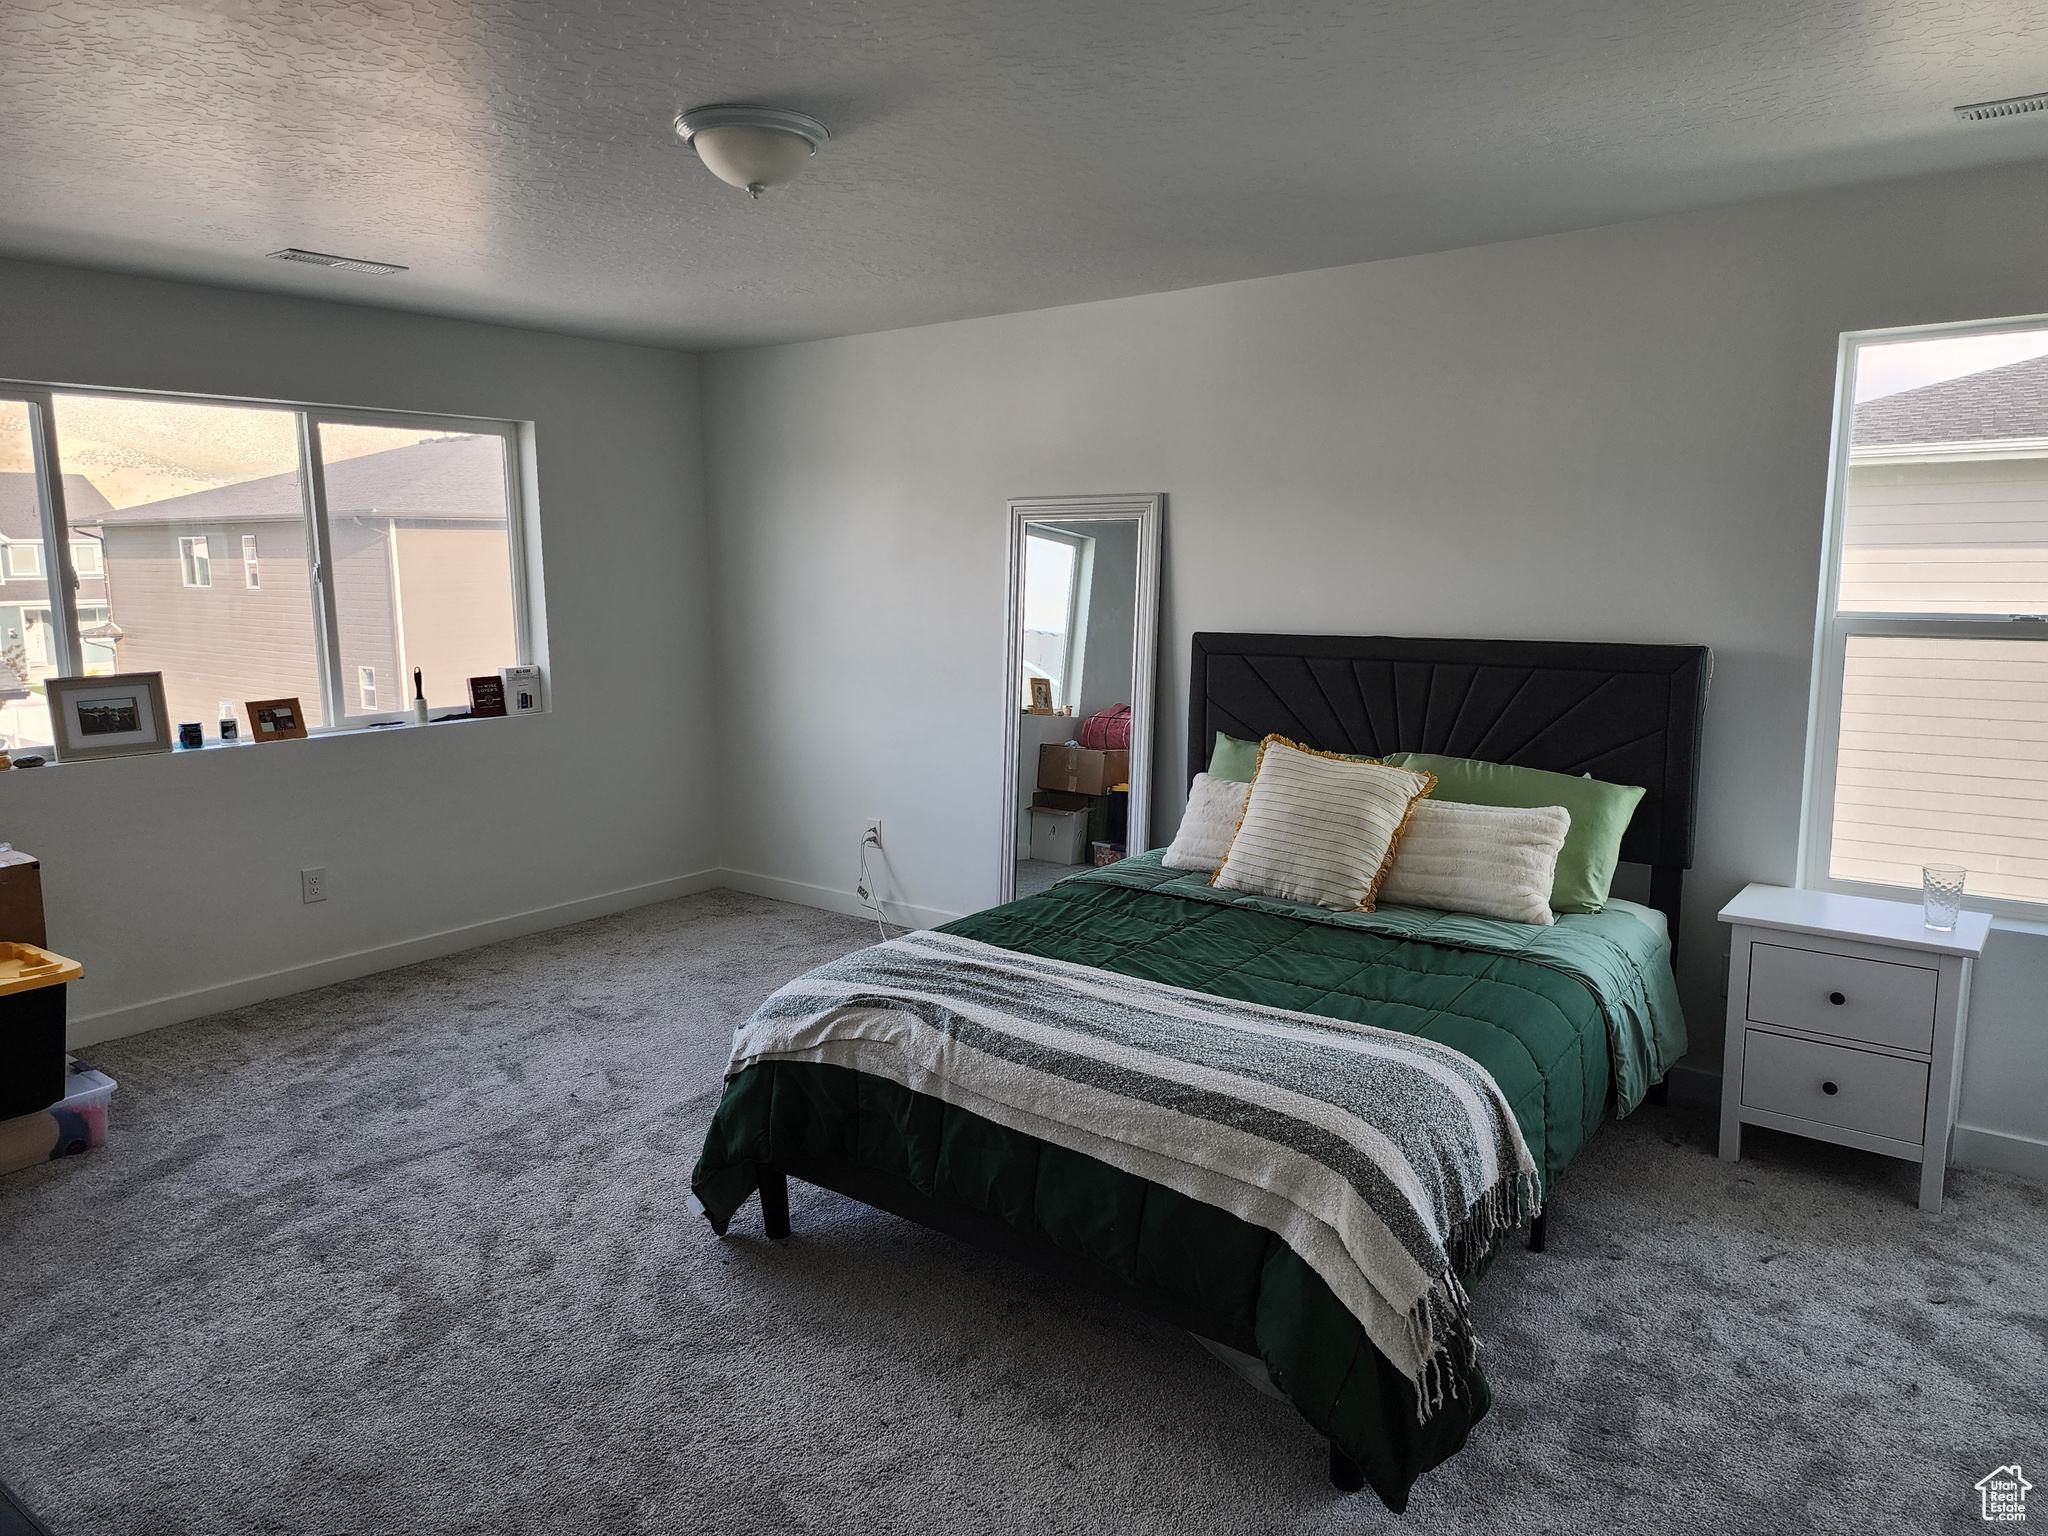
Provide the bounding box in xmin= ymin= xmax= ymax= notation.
xmin=690 ymin=854 xmax=1686 ymax=1511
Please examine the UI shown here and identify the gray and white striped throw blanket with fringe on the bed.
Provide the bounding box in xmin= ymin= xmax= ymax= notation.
xmin=727 ymin=934 xmax=1540 ymax=1417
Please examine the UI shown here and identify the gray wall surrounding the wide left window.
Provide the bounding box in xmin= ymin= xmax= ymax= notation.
xmin=0 ymin=262 xmax=717 ymax=1040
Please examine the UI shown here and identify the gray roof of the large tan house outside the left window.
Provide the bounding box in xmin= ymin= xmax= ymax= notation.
xmin=81 ymin=436 xmax=506 ymax=526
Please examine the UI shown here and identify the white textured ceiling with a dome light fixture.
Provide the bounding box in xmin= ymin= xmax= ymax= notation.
xmin=0 ymin=0 xmax=2048 ymax=346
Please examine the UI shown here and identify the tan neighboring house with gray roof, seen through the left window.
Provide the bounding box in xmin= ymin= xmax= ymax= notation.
xmin=74 ymin=436 xmax=518 ymax=729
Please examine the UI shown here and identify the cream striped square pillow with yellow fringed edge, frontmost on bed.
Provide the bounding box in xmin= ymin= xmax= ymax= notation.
xmin=1210 ymin=735 xmax=1436 ymax=911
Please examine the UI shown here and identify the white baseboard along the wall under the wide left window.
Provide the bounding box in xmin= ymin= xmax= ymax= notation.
xmin=66 ymin=868 xmax=727 ymax=1051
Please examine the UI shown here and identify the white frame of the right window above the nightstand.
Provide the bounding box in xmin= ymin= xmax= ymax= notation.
xmin=1794 ymin=315 xmax=2048 ymax=922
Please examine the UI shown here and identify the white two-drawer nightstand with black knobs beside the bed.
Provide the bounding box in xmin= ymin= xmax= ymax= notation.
xmin=1720 ymin=885 xmax=1991 ymax=1210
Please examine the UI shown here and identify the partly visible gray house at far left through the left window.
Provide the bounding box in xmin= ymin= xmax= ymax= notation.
xmin=0 ymin=471 xmax=115 ymax=750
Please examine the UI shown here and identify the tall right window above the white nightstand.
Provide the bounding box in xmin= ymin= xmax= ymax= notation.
xmin=1802 ymin=322 xmax=2048 ymax=913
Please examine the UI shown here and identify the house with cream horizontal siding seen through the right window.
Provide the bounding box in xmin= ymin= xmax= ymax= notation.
xmin=1831 ymin=356 xmax=2048 ymax=901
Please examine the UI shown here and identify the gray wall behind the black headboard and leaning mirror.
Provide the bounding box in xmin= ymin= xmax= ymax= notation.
xmin=707 ymin=166 xmax=2048 ymax=1167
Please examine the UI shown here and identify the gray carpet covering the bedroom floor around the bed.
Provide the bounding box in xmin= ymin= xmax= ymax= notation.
xmin=0 ymin=893 xmax=2048 ymax=1536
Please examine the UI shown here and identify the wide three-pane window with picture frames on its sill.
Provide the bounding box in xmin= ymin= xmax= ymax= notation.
xmin=0 ymin=383 xmax=532 ymax=745
